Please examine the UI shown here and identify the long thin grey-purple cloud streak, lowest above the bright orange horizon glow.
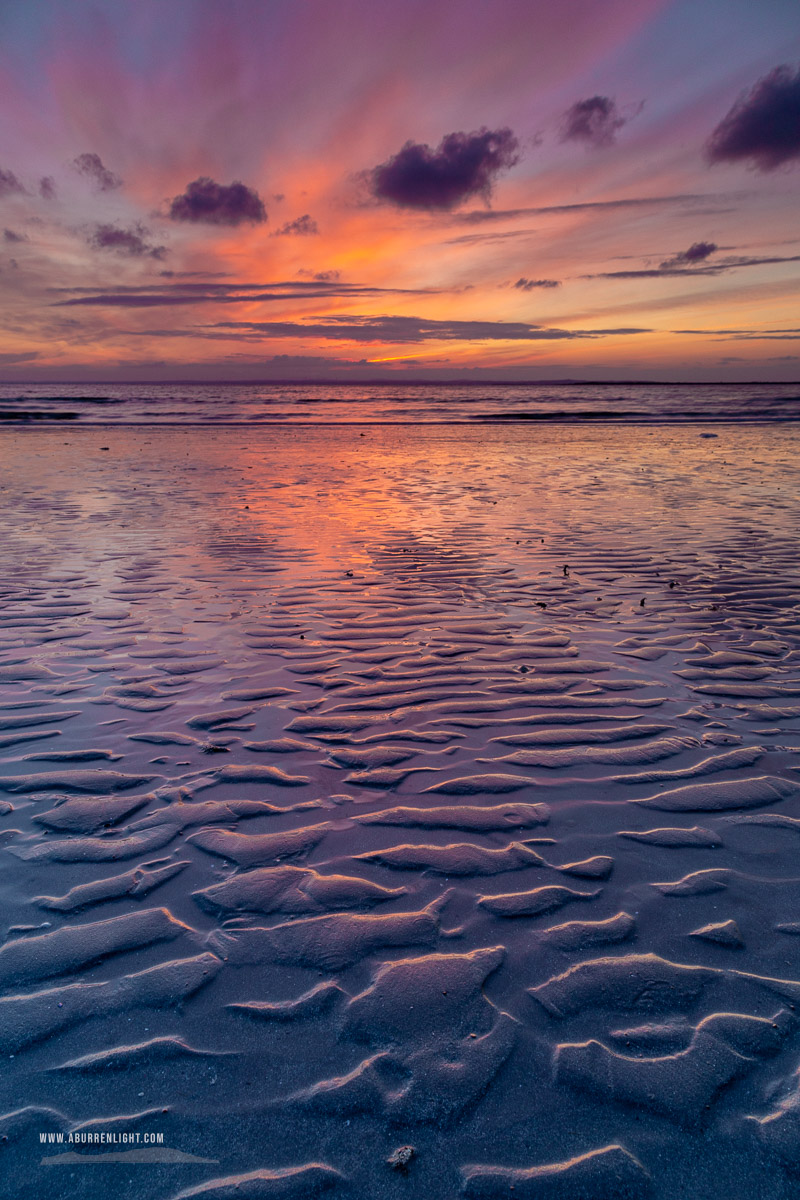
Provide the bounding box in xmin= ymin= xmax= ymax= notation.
xmin=209 ymin=316 xmax=649 ymax=344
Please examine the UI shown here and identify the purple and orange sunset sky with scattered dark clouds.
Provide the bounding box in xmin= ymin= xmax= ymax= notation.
xmin=0 ymin=0 xmax=800 ymax=382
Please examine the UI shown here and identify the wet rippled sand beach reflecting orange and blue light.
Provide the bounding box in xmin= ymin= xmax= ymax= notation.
xmin=0 ymin=426 xmax=800 ymax=1200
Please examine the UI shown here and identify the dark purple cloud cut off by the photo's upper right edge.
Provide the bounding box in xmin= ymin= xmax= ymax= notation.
xmin=705 ymin=66 xmax=800 ymax=170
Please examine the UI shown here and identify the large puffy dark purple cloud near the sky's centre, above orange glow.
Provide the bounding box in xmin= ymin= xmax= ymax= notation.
xmin=367 ymin=128 xmax=519 ymax=209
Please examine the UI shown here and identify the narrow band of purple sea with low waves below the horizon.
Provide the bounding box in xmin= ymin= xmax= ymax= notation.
xmin=0 ymin=382 xmax=800 ymax=425
